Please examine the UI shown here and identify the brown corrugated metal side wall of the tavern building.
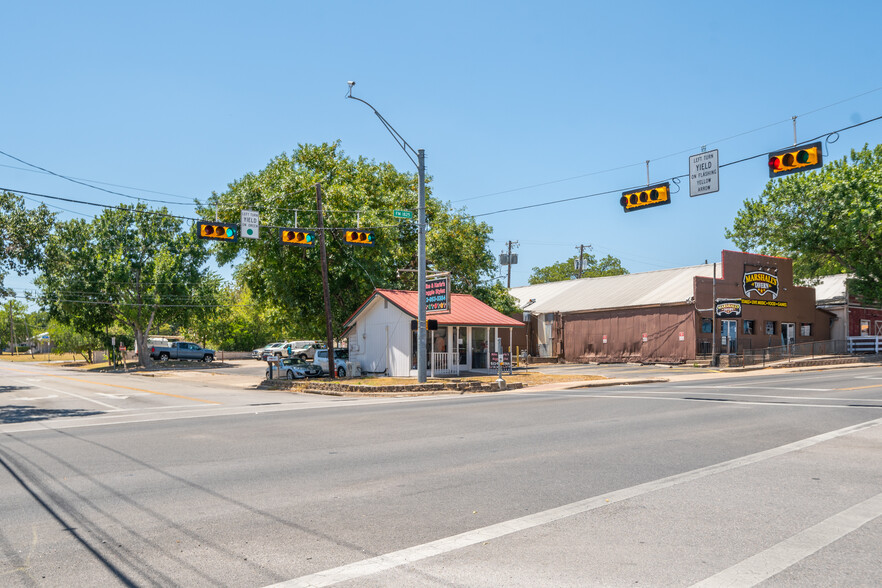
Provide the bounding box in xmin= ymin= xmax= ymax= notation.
xmin=561 ymin=304 xmax=696 ymax=362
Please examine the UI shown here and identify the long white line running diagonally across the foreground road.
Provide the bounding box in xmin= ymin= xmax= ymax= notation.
xmin=272 ymin=419 xmax=882 ymax=588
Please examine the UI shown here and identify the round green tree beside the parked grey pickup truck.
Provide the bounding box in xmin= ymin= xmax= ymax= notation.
xmin=36 ymin=204 xmax=217 ymax=366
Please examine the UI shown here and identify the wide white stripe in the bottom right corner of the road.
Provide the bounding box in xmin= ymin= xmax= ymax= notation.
xmin=692 ymin=494 xmax=882 ymax=588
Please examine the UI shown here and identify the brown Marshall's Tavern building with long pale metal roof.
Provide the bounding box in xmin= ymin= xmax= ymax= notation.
xmin=510 ymin=251 xmax=837 ymax=362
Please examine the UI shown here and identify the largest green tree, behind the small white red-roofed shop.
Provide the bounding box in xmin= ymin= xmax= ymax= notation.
xmin=200 ymin=143 xmax=495 ymax=339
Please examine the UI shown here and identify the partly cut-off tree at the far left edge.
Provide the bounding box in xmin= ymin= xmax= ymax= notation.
xmin=0 ymin=192 xmax=55 ymax=296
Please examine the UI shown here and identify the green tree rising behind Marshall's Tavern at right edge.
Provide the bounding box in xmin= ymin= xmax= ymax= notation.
xmin=726 ymin=145 xmax=882 ymax=300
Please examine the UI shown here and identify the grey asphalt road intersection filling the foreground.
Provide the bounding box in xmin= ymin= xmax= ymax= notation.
xmin=0 ymin=364 xmax=882 ymax=586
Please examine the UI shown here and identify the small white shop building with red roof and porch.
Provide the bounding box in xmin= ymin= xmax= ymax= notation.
xmin=342 ymin=289 xmax=525 ymax=377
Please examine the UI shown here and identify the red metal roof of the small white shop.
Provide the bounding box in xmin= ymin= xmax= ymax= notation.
xmin=343 ymin=288 xmax=526 ymax=328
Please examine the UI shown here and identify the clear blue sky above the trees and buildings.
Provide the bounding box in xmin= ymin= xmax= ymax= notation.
xmin=0 ymin=1 xmax=882 ymax=288
